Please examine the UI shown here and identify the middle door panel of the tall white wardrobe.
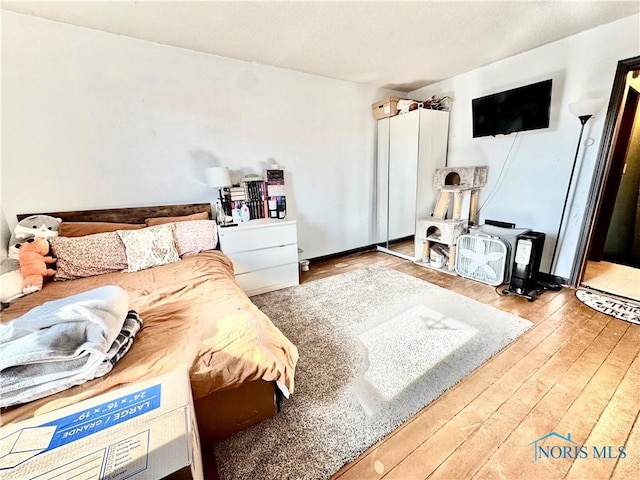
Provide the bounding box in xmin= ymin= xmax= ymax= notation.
xmin=388 ymin=110 xmax=420 ymax=240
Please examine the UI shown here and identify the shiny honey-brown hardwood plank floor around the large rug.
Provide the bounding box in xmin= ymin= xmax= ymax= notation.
xmin=301 ymin=244 xmax=640 ymax=480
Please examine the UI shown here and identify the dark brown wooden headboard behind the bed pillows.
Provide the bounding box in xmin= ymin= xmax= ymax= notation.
xmin=17 ymin=203 xmax=211 ymax=223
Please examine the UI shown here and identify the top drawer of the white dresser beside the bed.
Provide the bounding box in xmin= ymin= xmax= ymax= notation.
xmin=219 ymin=222 xmax=298 ymax=255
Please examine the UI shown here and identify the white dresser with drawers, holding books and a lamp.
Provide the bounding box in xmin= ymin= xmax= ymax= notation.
xmin=218 ymin=219 xmax=299 ymax=296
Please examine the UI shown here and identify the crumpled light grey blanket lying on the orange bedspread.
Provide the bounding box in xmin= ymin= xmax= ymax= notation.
xmin=0 ymin=285 xmax=129 ymax=407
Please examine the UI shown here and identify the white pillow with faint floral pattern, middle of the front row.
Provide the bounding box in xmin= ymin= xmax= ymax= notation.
xmin=117 ymin=223 xmax=180 ymax=272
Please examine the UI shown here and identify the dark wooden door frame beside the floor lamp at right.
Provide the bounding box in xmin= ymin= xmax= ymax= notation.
xmin=569 ymin=56 xmax=640 ymax=287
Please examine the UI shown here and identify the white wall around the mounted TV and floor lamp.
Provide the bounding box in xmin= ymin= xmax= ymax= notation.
xmin=411 ymin=15 xmax=640 ymax=278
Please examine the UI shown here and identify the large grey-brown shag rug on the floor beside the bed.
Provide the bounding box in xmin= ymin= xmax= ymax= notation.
xmin=215 ymin=266 xmax=532 ymax=480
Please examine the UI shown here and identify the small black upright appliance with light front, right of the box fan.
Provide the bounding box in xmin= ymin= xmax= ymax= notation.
xmin=508 ymin=232 xmax=545 ymax=298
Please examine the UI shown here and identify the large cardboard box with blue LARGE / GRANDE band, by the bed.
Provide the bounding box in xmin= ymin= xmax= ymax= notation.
xmin=0 ymin=370 xmax=204 ymax=480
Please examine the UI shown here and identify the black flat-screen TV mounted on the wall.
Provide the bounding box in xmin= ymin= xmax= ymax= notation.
xmin=471 ymin=79 xmax=551 ymax=138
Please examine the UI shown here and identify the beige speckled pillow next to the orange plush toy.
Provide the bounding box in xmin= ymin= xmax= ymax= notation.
xmin=49 ymin=232 xmax=127 ymax=280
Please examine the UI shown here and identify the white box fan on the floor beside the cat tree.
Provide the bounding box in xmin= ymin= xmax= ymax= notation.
xmin=456 ymin=235 xmax=509 ymax=285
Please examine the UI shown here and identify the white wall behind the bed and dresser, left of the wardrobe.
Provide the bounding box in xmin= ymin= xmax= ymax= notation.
xmin=1 ymin=12 xmax=400 ymax=258
